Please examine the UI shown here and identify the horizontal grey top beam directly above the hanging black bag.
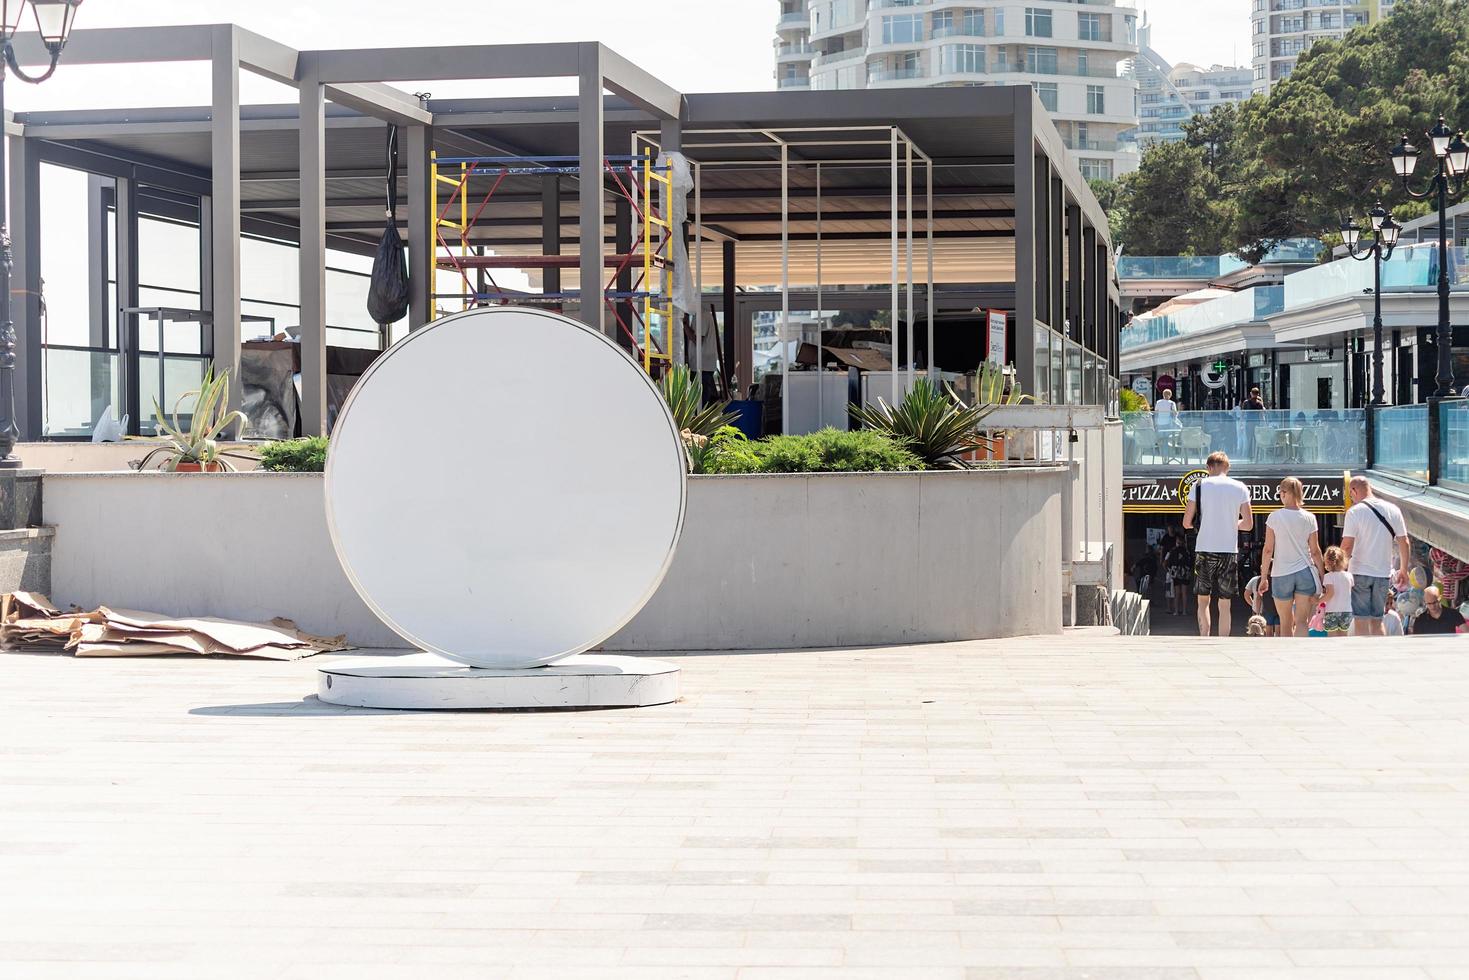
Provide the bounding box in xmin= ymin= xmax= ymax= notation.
xmin=306 ymin=43 xmax=583 ymax=85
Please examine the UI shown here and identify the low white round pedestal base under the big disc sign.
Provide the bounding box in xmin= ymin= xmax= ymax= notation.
xmin=316 ymin=654 xmax=679 ymax=711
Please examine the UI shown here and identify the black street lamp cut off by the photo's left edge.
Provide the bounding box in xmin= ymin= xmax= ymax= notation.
xmin=0 ymin=0 xmax=82 ymax=470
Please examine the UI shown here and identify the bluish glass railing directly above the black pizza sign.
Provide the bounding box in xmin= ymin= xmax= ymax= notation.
xmin=1122 ymin=408 xmax=1368 ymax=469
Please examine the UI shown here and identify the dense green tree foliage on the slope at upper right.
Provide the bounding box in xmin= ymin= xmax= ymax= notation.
xmin=1109 ymin=0 xmax=1469 ymax=262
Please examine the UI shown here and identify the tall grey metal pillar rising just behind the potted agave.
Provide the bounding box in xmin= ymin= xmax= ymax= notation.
xmin=208 ymin=26 xmax=244 ymax=420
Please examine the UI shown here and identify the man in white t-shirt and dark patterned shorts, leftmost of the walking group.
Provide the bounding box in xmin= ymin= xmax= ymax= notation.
xmin=1184 ymin=453 xmax=1255 ymax=636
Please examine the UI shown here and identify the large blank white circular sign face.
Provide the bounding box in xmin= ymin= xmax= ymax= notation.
xmin=326 ymin=307 xmax=686 ymax=667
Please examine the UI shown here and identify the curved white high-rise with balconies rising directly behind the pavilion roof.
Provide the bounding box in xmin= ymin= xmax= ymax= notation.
xmin=776 ymin=0 xmax=1137 ymax=178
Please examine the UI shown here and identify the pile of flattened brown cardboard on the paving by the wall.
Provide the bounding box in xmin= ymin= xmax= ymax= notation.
xmin=0 ymin=592 xmax=347 ymax=660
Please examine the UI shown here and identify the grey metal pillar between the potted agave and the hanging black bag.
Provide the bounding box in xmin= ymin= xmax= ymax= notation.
xmin=297 ymin=78 xmax=326 ymax=435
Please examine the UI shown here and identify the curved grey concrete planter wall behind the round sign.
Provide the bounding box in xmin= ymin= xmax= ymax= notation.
xmin=43 ymin=467 xmax=1066 ymax=649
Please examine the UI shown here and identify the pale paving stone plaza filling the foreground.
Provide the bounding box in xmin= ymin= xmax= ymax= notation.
xmin=0 ymin=632 xmax=1469 ymax=980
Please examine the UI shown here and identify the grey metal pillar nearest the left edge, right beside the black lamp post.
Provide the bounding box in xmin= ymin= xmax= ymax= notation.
xmin=4 ymin=134 xmax=46 ymax=441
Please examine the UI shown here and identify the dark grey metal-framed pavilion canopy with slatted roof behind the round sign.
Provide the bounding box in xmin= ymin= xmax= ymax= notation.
xmin=7 ymin=25 xmax=1118 ymax=438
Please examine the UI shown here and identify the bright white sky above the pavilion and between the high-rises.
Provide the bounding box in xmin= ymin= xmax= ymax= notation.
xmin=6 ymin=0 xmax=1250 ymax=110
